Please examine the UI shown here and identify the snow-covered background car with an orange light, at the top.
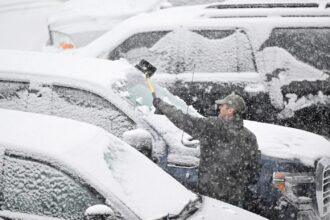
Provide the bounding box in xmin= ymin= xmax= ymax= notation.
xmin=45 ymin=0 xmax=170 ymax=50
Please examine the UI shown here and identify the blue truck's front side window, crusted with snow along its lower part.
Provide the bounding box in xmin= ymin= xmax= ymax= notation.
xmin=52 ymin=86 xmax=136 ymax=138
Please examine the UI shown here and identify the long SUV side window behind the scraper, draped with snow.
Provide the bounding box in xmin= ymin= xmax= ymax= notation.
xmin=108 ymin=28 xmax=256 ymax=74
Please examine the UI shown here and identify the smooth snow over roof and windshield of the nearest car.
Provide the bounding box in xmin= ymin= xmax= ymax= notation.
xmin=0 ymin=109 xmax=197 ymax=219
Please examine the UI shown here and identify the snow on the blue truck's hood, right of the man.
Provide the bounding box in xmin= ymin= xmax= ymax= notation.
xmin=244 ymin=120 xmax=330 ymax=166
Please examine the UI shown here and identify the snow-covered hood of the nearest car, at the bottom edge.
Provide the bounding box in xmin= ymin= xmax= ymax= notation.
xmin=188 ymin=196 xmax=266 ymax=220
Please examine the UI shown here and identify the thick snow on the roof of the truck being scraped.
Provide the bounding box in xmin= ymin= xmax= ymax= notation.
xmin=0 ymin=50 xmax=130 ymax=87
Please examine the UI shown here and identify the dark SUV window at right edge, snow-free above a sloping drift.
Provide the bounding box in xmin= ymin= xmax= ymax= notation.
xmin=260 ymin=27 xmax=330 ymax=71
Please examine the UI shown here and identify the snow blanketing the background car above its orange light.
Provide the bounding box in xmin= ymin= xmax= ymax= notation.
xmin=48 ymin=0 xmax=162 ymax=37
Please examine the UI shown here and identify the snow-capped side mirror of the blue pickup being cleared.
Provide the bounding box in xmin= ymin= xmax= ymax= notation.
xmin=123 ymin=128 xmax=152 ymax=158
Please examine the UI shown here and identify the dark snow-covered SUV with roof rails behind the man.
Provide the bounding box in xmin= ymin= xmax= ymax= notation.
xmin=75 ymin=0 xmax=330 ymax=137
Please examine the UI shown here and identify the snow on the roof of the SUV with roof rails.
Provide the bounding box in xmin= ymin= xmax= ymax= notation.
xmin=74 ymin=2 xmax=330 ymax=57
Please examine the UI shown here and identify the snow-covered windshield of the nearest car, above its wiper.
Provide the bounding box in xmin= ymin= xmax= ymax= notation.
xmin=101 ymin=138 xmax=197 ymax=219
